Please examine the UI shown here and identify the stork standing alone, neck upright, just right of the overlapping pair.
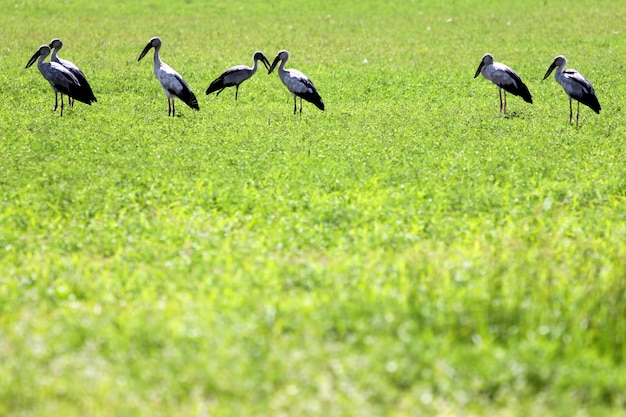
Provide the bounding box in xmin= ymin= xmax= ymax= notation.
xmin=137 ymin=36 xmax=200 ymax=117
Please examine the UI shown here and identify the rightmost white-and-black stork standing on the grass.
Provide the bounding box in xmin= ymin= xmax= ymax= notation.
xmin=543 ymin=55 xmax=602 ymax=126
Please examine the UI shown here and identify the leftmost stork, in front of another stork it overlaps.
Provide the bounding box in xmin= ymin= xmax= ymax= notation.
xmin=26 ymin=45 xmax=93 ymax=116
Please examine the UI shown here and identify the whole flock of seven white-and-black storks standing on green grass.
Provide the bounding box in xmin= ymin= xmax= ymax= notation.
xmin=26 ymin=36 xmax=601 ymax=126
